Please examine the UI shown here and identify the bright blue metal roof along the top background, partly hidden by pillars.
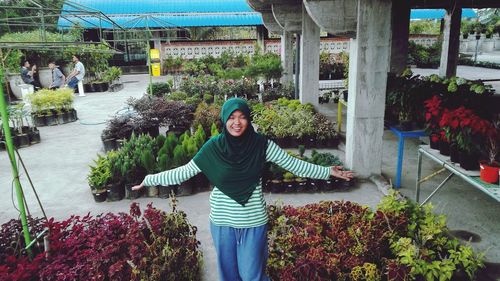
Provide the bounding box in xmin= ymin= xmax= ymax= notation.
xmin=58 ymin=0 xmax=476 ymax=28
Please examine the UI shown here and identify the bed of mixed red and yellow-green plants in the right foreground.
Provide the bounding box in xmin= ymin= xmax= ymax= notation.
xmin=267 ymin=191 xmax=483 ymax=281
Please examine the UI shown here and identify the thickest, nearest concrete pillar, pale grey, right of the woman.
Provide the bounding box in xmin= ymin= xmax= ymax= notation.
xmin=346 ymin=0 xmax=392 ymax=177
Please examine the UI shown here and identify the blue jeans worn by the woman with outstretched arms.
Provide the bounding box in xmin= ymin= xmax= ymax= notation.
xmin=210 ymin=222 xmax=269 ymax=281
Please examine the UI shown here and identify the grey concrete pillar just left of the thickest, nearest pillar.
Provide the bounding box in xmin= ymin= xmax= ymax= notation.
xmin=299 ymin=4 xmax=320 ymax=107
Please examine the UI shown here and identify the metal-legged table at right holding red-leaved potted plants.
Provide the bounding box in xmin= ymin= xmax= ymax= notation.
xmin=415 ymin=145 xmax=500 ymax=205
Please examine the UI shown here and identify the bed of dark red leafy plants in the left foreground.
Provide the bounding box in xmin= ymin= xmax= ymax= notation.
xmin=0 ymin=202 xmax=202 ymax=281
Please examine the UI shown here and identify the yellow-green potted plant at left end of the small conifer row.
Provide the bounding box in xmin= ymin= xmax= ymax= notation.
xmin=87 ymin=154 xmax=111 ymax=202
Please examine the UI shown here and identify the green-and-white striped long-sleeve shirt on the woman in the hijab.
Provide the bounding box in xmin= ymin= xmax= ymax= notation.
xmin=144 ymin=141 xmax=330 ymax=228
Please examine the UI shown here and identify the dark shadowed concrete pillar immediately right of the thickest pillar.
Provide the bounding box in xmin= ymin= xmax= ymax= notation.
xmin=391 ymin=1 xmax=410 ymax=74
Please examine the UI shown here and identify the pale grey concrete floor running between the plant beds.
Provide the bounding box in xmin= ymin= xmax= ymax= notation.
xmin=0 ymin=72 xmax=500 ymax=280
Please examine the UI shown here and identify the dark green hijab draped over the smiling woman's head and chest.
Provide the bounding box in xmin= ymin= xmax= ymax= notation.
xmin=193 ymin=98 xmax=267 ymax=205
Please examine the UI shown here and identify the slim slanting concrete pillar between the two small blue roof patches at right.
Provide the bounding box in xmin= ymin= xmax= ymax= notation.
xmin=439 ymin=6 xmax=462 ymax=77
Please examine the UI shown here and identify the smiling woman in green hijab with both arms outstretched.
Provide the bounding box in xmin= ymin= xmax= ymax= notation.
xmin=133 ymin=98 xmax=353 ymax=281
